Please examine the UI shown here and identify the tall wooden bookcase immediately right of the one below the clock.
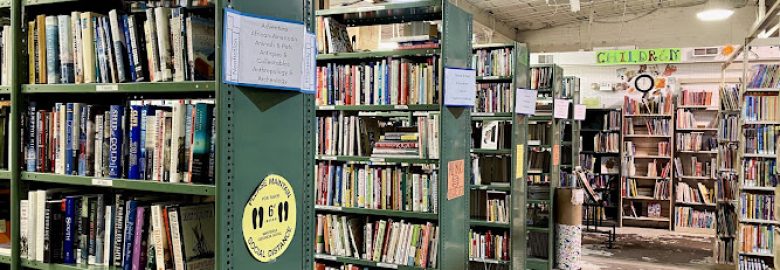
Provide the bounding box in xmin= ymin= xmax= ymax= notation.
xmin=674 ymin=89 xmax=719 ymax=235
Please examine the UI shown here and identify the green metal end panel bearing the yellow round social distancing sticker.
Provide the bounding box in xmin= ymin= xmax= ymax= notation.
xmin=215 ymin=0 xmax=315 ymax=270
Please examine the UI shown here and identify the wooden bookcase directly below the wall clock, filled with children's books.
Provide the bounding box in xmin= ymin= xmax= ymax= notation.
xmin=620 ymin=93 xmax=675 ymax=229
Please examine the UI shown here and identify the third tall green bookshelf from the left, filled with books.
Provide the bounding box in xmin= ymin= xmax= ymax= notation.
xmin=468 ymin=43 xmax=529 ymax=270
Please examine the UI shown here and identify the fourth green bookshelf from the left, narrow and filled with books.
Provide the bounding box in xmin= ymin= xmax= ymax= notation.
xmin=525 ymin=64 xmax=567 ymax=269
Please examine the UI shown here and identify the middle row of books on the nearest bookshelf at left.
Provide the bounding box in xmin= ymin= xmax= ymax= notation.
xmin=23 ymin=100 xmax=216 ymax=183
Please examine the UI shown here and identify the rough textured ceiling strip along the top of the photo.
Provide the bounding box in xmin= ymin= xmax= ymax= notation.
xmin=460 ymin=0 xmax=706 ymax=31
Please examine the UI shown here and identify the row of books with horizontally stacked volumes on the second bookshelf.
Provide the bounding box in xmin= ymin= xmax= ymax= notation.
xmin=317 ymin=112 xmax=439 ymax=159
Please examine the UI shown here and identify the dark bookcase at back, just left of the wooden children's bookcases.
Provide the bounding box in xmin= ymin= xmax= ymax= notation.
xmin=579 ymin=109 xmax=622 ymax=221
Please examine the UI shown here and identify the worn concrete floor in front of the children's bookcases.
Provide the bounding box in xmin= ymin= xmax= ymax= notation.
xmin=582 ymin=228 xmax=715 ymax=270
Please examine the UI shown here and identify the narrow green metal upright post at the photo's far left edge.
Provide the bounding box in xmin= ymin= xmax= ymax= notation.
xmin=9 ymin=0 xmax=23 ymax=270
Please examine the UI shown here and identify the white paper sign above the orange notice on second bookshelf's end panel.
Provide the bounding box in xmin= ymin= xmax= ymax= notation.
xmin=444 ymin=68 xmax=477 ymax=107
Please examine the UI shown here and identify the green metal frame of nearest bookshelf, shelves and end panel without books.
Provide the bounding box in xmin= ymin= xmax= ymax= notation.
xmin=0 ymin=0 xmax=314 ymax=270
